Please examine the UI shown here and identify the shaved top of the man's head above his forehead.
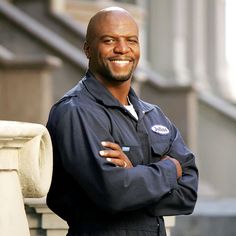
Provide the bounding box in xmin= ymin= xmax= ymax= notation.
xmin=86 ymin=7 xmax=138 ymax=42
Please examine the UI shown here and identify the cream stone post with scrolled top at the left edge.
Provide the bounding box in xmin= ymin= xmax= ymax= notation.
xmin=0 ymin=121 xmax=52 ymax=236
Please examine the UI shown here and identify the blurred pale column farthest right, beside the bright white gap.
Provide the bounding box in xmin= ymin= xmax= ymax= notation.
xmin=205 ymin=0 xmax=231 ymax=99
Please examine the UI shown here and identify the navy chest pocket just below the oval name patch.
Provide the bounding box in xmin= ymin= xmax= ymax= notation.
xmin=151 ymin=139 xmax=169 ymax=161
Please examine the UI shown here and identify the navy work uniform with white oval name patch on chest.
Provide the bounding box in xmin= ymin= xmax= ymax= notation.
xmin=47 ymin=72 xmax=198 ymax=236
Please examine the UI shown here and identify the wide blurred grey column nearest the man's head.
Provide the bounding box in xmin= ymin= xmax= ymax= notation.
xmin=147 ymin=0 xmax=189 ymax=84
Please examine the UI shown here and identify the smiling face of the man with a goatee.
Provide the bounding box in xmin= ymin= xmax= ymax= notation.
xmin=85 ymin=14 xmax=140 ymax=82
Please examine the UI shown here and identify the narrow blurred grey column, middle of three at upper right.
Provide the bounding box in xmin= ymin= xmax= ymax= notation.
xmin=187 ymin=0 xmax=210 ymax=91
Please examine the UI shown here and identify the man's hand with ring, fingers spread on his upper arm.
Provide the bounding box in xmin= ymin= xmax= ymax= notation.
xmin=99 ymin=141 xmax=133 ymax=169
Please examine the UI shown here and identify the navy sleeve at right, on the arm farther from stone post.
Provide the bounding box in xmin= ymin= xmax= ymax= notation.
xmin=148 ymin=125 xmax=198 ymax=216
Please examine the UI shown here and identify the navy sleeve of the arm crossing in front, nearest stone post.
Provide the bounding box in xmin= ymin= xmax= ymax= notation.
xmin=47 ymin=103 xmax=179 ymax=213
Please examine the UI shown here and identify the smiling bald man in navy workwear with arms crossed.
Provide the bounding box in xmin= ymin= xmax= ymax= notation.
xmin=47 ymin=7 xmax=198 ymax=236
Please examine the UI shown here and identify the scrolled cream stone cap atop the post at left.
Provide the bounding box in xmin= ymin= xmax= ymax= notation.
xmin=0 ymin=121 xmax=52 ymax=197
